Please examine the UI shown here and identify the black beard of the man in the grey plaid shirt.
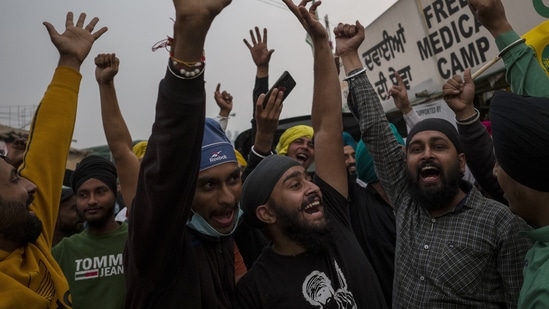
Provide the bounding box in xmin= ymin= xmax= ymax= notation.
xmin=406 ymin=161 xmax=463 ymax=211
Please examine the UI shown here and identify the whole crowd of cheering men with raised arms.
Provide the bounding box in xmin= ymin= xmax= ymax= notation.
xmin=0 ymin=0 xmax=549 ymax=308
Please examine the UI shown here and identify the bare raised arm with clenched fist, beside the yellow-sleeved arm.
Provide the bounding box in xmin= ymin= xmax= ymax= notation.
xmin=95 ymin=54 xmax=139 ymax=216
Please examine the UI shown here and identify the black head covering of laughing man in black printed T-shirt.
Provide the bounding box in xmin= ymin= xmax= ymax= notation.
xmin=240 ymin=155 xmax=300 ymax=228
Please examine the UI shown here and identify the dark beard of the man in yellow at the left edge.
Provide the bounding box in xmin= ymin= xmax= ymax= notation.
xmin=0 ymin=200 xmax=43 ymax=246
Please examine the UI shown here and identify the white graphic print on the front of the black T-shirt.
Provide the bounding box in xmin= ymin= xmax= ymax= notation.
xmin=302 ymin=260 xmax=357 ymax=309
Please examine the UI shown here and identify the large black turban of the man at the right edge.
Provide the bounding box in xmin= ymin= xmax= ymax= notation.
xmin=490 ymin=91 xmax=549 ymax=192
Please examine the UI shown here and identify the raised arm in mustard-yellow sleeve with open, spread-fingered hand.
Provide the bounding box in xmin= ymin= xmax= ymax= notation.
xmin=20 ymin=12 xmax=107 ymax=246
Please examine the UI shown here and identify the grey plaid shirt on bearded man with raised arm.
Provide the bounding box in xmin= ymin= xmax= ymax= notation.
xmin=348 ymin=71 xmax=531 ymax=309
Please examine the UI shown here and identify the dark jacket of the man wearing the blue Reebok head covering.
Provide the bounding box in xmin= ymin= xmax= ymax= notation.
xmin=124 ymin=66 xmax=235 ymax=309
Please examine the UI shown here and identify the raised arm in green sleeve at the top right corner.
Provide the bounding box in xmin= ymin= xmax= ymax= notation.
xmin=468 ymin=0 xmax=549 ymax=98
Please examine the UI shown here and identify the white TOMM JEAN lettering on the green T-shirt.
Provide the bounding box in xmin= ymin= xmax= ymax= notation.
xmin=74 ymin=253 xmax=124 ymax=281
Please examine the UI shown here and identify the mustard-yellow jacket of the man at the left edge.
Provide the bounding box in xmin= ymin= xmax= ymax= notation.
xmin=0 ymin=67 xmax=78 ymax=309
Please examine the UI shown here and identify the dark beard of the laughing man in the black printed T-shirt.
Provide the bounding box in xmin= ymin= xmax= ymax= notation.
xmin=269 ymin=200 xmax=334 ymax=253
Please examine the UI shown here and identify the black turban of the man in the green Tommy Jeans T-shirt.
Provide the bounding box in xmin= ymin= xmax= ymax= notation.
xmin=71 ymin=156 xmax=117 ymax=195
